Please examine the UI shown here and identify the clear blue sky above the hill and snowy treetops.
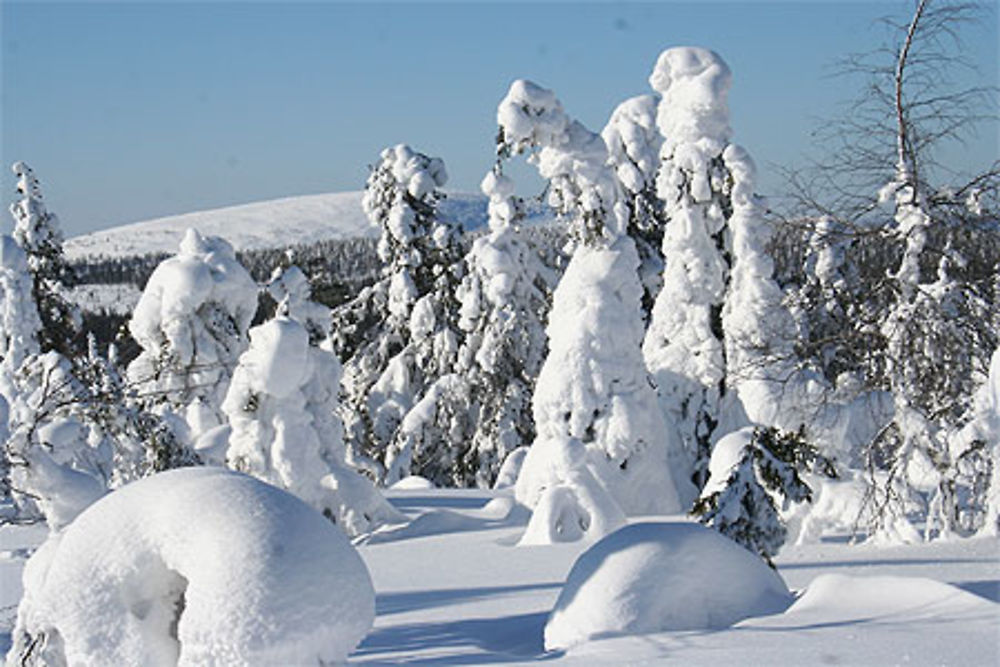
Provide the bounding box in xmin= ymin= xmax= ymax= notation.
xmin=0 ymin=0 xmax=1000 ymax=236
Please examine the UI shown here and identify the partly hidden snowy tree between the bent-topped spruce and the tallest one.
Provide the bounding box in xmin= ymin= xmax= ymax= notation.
xmin=601 ymin=95 xmax=664 ymax=323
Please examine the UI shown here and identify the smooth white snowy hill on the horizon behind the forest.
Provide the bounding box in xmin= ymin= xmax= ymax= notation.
xmin=65 ymin=191 xmax=486 ymax=260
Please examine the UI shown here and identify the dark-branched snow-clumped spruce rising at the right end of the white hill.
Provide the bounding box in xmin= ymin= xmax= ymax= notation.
xmin=333 ymin=145 xmax=461 ymax=480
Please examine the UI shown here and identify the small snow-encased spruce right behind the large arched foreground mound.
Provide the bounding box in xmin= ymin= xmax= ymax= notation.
xmin=222 ymin=314 xmax=404 ymax=536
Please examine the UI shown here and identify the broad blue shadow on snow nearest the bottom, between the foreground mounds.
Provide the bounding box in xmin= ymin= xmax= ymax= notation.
xmin=350 ymin=612 xmax=562 ymax=665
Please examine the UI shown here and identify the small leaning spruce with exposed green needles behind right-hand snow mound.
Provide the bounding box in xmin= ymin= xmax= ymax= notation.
xmin=691 ymin=427 xmax=836 ymax=567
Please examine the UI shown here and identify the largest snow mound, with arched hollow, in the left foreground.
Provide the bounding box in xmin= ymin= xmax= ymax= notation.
xmin=9 ymin=468 xmax=375 ymax=665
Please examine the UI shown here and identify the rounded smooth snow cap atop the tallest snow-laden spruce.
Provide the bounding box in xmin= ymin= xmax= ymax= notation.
xmin=649 ymin=46 xmax=732 ymax=151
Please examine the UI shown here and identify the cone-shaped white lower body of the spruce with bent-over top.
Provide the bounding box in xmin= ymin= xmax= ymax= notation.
xmin=517 ymin=238 xmax=680 ymax=515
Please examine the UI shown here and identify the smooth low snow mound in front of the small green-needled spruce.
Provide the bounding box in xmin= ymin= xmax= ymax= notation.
xmin=545 ymin=522 xmax=792 ymax=650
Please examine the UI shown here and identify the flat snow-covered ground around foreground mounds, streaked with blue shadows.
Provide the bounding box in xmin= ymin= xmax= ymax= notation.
xmin=0 ymin=489 xmax=1000 ymax=665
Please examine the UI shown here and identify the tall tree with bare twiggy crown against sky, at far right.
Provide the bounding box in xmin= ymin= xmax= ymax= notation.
xmin=790 ymin=0 xmax=1000 ymax=539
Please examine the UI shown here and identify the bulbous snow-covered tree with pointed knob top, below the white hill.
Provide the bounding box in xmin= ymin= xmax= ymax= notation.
xmin=128 ymin=229 xmax=258 ymax=441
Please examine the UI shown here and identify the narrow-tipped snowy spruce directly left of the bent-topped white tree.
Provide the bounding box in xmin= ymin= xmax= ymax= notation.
xmin=400 ymin=162 xmax=548 ymax=487
